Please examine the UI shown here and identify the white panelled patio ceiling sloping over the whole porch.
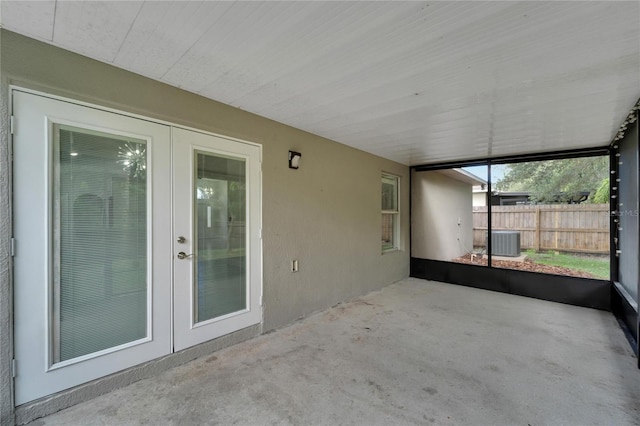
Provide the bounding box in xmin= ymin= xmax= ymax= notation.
xmin=0 ymin=0 xmax=640 ymax=165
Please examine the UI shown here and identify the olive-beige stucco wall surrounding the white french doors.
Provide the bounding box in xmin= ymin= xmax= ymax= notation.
xmin=0 ymin=30 xmax=409 ymax=422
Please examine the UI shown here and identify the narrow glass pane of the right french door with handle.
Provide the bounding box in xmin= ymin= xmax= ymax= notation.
xmin=194 ymin=152 xmax=247 ymax=322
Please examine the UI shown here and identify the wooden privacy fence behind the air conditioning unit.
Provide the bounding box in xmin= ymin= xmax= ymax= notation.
xmin=473 ymin=204 xmax=609 ymax=253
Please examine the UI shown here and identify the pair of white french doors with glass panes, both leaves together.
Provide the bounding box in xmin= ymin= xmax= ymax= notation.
xmin=13 ymin=90 xmax=262 ymax=405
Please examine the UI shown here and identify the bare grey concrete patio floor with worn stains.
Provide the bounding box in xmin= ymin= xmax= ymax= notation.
xmin=31 ymin=278 xmax=640 ymax=426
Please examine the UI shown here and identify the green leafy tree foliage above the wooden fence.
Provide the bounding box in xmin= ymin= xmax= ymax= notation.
xmin=495 ymin=157 xmax=609 ymax=203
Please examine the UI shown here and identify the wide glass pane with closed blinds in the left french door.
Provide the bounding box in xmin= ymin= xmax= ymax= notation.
xmin=52 ymin=124 xmax=149 ymax=363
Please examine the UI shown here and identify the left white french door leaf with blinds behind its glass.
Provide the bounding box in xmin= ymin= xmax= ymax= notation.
xmin=13 ymin=91 xmax=171 ymax=404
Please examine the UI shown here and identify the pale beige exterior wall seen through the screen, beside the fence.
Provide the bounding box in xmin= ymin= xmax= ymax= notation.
xmin=411 ymin=171 xmax=473 ymax=261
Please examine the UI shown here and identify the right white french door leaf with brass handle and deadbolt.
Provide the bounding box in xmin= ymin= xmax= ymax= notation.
xmin=173 ymin=128 xmax=262 ymax=350
